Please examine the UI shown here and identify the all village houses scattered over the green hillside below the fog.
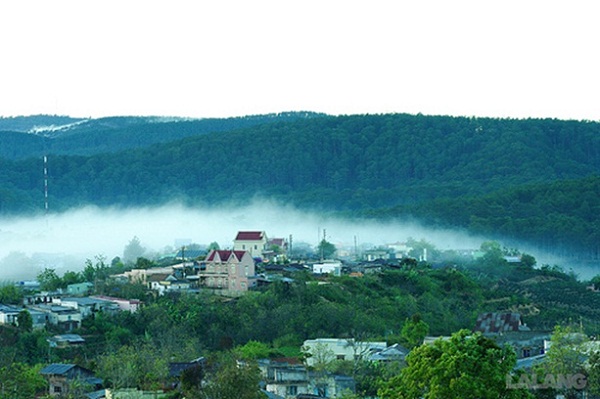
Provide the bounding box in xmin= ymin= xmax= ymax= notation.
xmin=0 ymin=231 xmax=592 ymax=399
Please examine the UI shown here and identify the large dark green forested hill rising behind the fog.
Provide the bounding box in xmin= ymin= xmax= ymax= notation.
xmin=0 ymin=114 xmax=600 ymax=252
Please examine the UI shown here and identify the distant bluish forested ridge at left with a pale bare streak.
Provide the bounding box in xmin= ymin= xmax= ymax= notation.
xmin=0 ymin=112 xmax=323 ymax=159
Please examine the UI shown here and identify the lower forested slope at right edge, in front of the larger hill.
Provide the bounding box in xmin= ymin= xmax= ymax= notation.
xmin=363 ymin=176 xmax=600 ymax=260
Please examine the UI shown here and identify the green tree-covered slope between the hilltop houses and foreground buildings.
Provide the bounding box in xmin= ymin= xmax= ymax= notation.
xmin=0 ymin=248 xmax=600 ymax=398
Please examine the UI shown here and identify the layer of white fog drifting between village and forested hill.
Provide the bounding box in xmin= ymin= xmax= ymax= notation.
xmin=0 ymin=201 xmax=596 ymax=281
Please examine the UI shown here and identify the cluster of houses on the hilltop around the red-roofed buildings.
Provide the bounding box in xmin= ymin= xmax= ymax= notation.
xmin=108 ymin=231 xmax=420 ymax=296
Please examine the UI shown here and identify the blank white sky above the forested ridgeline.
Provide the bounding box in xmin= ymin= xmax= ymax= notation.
xmin=0 ymin=0 xmax=600 ymax=120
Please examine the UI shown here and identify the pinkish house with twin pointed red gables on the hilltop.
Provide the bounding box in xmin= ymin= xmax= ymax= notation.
xmin=198 ymin=250 xmax=255 ymax=292
